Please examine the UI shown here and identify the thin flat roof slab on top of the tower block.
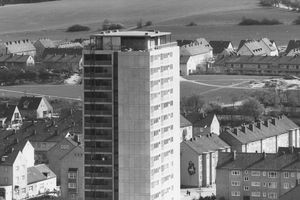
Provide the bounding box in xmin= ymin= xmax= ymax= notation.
xmin=92 ymin=30 xmax=171 ymax=37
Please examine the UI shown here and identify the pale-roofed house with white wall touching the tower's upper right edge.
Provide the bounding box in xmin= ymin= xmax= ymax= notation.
xmin=179 ymin=38 xmax=213 ymax=75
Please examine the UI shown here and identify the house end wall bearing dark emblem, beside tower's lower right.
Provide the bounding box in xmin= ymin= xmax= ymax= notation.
xmin=180 ymin=143 xmax=202 ymax=187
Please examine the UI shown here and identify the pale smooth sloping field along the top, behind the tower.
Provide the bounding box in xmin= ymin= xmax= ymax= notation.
xmin=0 ymin=0 xmax=257 ymax=34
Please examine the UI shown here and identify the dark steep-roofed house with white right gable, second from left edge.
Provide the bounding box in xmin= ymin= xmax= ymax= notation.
xmin=18 ymin=96 xmax=53 ymax=119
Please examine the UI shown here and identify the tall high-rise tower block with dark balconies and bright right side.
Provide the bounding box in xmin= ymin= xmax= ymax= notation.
xmin=83 ymin=31 xmax=180 ymax=200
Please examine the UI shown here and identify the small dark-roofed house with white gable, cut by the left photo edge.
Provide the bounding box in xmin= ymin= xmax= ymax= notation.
xmin=0 ymin=104 xmax=22 ymax=129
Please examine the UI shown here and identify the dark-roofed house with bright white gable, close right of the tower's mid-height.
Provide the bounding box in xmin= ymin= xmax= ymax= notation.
xmin=186 ymin=113 xmax=220 ymax=136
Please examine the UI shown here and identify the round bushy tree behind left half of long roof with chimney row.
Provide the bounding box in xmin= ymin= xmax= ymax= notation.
xmin=239 ymin=97 xmax=265 ymax=120
